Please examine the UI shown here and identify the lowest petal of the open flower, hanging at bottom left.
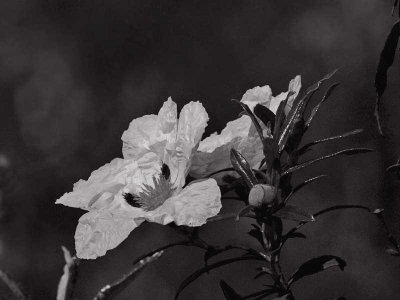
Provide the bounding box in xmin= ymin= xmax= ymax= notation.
xmin=75 ymin=204 xmax=144 ymax=259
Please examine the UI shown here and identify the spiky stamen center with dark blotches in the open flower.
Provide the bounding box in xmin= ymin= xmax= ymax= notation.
xmin=123 ymin=164 xmax=175 ymax=211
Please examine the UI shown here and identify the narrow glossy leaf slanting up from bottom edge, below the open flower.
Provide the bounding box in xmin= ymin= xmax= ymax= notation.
xmin=94 ymin=251 xmax=164 ymax=300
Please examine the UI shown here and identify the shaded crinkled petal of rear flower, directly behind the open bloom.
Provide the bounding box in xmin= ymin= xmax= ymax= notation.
xmin=190 ymin=116 xmax=263 ymax=181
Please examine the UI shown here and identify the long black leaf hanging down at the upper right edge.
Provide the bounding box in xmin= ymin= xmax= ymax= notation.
xmin=374 ymin=21 xmax=400 ymax=135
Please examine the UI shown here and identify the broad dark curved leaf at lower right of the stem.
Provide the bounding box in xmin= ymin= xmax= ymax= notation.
xmin=288 ymin=255 xmax=346 ymax=286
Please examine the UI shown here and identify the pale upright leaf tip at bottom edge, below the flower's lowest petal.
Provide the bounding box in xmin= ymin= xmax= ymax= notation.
xmin=57 ymin=246 xmax=79 ymax=300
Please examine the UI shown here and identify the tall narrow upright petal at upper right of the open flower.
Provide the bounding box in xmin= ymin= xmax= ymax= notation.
xmin=165 ymin=102 xmax=208 ymax=188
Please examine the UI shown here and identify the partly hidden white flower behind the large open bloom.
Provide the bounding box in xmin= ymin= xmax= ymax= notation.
xmin=190 ymin=75 xmax=301 ymax=179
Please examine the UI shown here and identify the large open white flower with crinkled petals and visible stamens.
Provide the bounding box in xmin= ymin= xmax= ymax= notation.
xmin=56 ymin=99 xmax=221 ymax=259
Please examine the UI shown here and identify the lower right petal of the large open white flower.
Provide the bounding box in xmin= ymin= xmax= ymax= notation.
xmin=146 ymin=179 xmax=222 ymax=227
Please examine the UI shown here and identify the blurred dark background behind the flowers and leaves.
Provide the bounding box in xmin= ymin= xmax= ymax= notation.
xmin=0 ymin=0 xmax=400 ymax=300
